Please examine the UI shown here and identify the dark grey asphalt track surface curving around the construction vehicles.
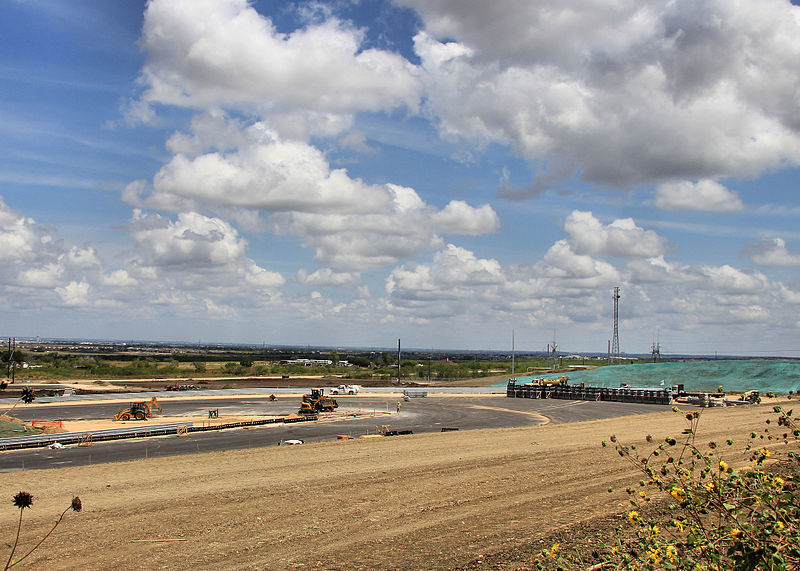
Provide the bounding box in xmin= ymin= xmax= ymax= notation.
xmin=0 ymin=395 xmax=670 ymax=472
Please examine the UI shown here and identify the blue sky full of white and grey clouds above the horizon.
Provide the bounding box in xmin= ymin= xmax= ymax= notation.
xmin=0 ymin=0 xmax=800 ymax=356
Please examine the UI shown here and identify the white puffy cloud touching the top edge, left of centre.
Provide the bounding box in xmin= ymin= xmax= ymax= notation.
xmin=133 ymin=0 xmax=420 ymax=136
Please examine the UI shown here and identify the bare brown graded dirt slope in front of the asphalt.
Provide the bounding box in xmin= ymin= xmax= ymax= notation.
xmin=0 ymin=399 xmax=792 ymax=570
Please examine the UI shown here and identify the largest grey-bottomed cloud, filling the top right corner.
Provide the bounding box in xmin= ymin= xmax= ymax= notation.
xmin=402 ymin=0 xmax=800 ymax=192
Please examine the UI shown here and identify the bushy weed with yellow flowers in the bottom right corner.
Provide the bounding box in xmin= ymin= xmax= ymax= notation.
xmin=536 ymin=406 xmax=800 ymax=571
